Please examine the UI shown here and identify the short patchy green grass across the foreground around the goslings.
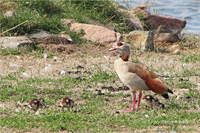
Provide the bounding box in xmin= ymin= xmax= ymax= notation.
xmin=0 ymin=62 xmax=200 ymax=132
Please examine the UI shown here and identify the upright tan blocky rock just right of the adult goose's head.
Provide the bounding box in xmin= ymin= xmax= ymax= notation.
xmin=125 ymin=30 xmax=154 ymax=51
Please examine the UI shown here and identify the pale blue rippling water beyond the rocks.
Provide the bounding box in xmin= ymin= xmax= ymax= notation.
xmin=116 ymin=0 xmax=200 ymax=35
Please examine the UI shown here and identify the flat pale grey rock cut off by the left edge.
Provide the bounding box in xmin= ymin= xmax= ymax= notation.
xmin=0 ymin=36 xmax=32 ymax=48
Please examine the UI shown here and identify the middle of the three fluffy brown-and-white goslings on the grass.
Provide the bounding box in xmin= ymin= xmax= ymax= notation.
xmin=58 ymin=97 xmax=74 ymax=111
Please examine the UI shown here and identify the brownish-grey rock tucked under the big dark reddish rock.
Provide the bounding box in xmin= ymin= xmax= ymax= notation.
xmin=155 ymin=25 xmax=180 ymax=43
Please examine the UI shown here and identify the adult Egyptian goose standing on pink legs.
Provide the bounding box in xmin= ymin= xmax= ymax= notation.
xmin=109 ymin=42 xmax=173 ymax=111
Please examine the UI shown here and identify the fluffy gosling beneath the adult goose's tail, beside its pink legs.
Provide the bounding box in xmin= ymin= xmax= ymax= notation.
xmin=141 ymin=95 xmax=165 ymax=109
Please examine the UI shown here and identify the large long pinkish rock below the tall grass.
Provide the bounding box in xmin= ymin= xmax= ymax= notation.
xmin=70 ymin=23 xmax=121 ymax=44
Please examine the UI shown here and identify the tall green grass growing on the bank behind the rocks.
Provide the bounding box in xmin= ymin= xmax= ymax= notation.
xmin=0 ymin=0 xmax=131 ymax=37
